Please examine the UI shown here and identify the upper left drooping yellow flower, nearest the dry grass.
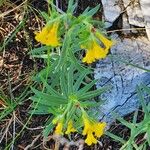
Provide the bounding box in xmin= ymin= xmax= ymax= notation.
xmin=35 ymin=22 xmax=60 ymax=47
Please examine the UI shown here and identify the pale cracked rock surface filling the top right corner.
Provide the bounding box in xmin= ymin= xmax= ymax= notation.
xmin=101 ymin=0 xmax=150 ymax=40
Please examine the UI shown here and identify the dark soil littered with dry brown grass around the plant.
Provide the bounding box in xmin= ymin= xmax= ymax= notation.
xmin=0 ymin=0 xmax=146 ymax=150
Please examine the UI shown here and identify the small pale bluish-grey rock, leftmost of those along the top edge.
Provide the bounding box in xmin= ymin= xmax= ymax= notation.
xmin=101 ymin=0 xmax=121 ymax=24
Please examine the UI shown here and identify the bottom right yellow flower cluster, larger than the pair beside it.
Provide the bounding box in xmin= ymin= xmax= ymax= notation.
xmin=82 ymin=116 xmax=106 ymax=145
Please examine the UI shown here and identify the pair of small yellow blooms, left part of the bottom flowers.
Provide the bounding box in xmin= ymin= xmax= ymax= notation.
xmin=55 ymin=120 xmax=76 ymax=135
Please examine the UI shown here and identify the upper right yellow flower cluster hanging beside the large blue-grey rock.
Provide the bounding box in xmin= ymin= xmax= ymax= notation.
xmin=81 ymin=32 xmax=113 ymax=64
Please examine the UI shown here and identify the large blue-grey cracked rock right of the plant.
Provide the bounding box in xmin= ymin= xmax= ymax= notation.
xmin=94 ymin=35 xmax=150 ymax=123
